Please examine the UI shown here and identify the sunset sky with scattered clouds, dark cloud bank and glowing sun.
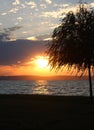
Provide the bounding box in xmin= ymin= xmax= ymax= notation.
xmin=0 ymin=0 xmax=94 ymax=76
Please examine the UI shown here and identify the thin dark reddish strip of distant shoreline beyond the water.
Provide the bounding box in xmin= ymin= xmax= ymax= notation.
xmin=0 ymin=75 xmax=91 ymax=80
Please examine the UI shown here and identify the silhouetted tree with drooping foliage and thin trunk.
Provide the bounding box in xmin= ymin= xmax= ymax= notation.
xmin=48 ymin=4 xmax=94 ymax=98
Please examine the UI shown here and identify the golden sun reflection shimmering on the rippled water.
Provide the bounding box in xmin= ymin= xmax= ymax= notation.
xmin=33 ymin=80 xmax=50 ymax=94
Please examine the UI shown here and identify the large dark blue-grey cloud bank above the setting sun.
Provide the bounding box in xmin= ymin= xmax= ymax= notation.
xmin=0 ymin=40 xmax=47 ymax=65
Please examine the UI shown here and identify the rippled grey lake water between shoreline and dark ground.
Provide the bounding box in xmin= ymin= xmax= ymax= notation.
xmin=0 ymin=80 xmax=94 ymax=96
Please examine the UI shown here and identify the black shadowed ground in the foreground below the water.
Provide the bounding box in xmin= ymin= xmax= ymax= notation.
xmin=0 ymin=95 xmax=94 ymax=130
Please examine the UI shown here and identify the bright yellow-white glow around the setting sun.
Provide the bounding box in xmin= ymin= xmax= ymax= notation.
xmin=26 ymin=55 xmax=54 ymax=76
